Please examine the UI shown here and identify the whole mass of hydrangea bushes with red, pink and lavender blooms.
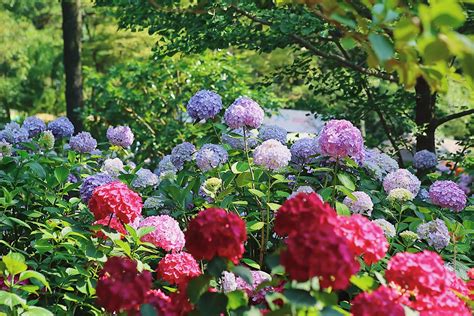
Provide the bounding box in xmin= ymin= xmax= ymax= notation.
xmin=0 ymin=90 xmax=474 ymax=316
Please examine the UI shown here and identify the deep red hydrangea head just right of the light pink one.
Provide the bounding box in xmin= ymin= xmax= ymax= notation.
xmin=185 ymin=208 xmax=247 ymax=263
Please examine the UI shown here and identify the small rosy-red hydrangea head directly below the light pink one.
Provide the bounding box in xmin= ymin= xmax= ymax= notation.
xmin=156 ymin=252 xmax=201 ymax=288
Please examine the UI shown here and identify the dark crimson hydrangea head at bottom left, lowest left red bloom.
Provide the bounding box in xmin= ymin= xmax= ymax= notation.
xmin=96 ymin=257 xmax=152 ymax=313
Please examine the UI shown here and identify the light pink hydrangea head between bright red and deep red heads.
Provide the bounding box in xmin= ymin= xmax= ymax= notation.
xmin=138 ymin=215 xmax=185 ymax=252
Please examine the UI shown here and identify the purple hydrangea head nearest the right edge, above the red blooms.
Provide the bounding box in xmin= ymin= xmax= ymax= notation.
xmin=430 ymin=180 xmax=467 ymax=212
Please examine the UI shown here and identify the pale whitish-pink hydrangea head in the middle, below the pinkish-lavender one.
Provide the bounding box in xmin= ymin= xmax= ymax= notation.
xmin=253 ymin=139 xmax=291 ymax=170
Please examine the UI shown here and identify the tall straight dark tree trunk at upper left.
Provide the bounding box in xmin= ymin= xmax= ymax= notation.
xmin=61 ymin=0 xmax=83 ymax=131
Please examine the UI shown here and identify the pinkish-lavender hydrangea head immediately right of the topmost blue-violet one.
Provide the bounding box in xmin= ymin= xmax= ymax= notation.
xmin=224 ymin=97 xmax=264 ymax=129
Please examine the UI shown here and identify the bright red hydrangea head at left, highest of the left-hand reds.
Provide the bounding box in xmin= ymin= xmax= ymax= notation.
xmin=89 ymin=181 xmax=142 ymax=224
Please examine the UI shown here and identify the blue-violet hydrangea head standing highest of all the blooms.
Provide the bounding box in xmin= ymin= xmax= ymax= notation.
xmin=186 ymin=90 xmax=222 ymax=121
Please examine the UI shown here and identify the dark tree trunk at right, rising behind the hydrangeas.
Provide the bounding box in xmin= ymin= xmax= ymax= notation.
xmin=415 ymin=77 xmax=436 ymax=152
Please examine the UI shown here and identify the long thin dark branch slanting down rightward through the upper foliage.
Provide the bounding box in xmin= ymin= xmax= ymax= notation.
xmin=231 ymin=5 xmax=397 ymax=83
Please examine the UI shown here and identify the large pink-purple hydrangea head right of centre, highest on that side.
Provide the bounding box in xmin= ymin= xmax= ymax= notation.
xmin=319 ymin=120 xmax=364 ymax=161
